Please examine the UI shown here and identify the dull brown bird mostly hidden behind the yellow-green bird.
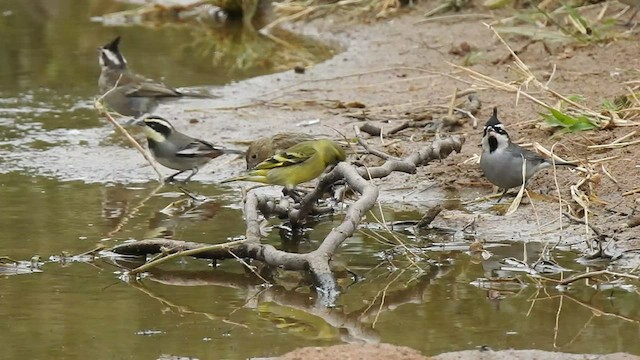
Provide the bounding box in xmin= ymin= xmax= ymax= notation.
xmin=246 ymin=132 xmax=313 ymax=170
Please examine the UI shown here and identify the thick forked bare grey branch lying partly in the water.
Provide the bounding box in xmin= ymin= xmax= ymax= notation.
xmin=111 ymin=136 xmax=464 ymax=305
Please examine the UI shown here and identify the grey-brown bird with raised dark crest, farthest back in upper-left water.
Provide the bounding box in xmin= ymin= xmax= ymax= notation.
xmin=98 ymin=36 xmax=211 ymax=117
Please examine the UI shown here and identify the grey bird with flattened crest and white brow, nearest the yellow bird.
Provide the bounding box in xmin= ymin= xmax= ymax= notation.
xmin=136 ymin=116 xmax=244 ymax=182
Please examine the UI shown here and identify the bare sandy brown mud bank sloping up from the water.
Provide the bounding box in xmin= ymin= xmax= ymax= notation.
xmin=172 ymin=3 xmax=640 ymax=256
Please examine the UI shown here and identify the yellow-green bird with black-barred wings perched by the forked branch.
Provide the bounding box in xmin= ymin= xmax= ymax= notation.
xmin=222 ymin=139 xmax=347 ymax=190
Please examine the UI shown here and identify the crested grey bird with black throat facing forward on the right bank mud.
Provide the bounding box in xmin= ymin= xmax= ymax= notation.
xmin=480 ymin=107 xmax=576 ymax=200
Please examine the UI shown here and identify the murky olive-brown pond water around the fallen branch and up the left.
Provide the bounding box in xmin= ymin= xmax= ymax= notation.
xmin=0 ymin=0 xmax=640 ymax=359
